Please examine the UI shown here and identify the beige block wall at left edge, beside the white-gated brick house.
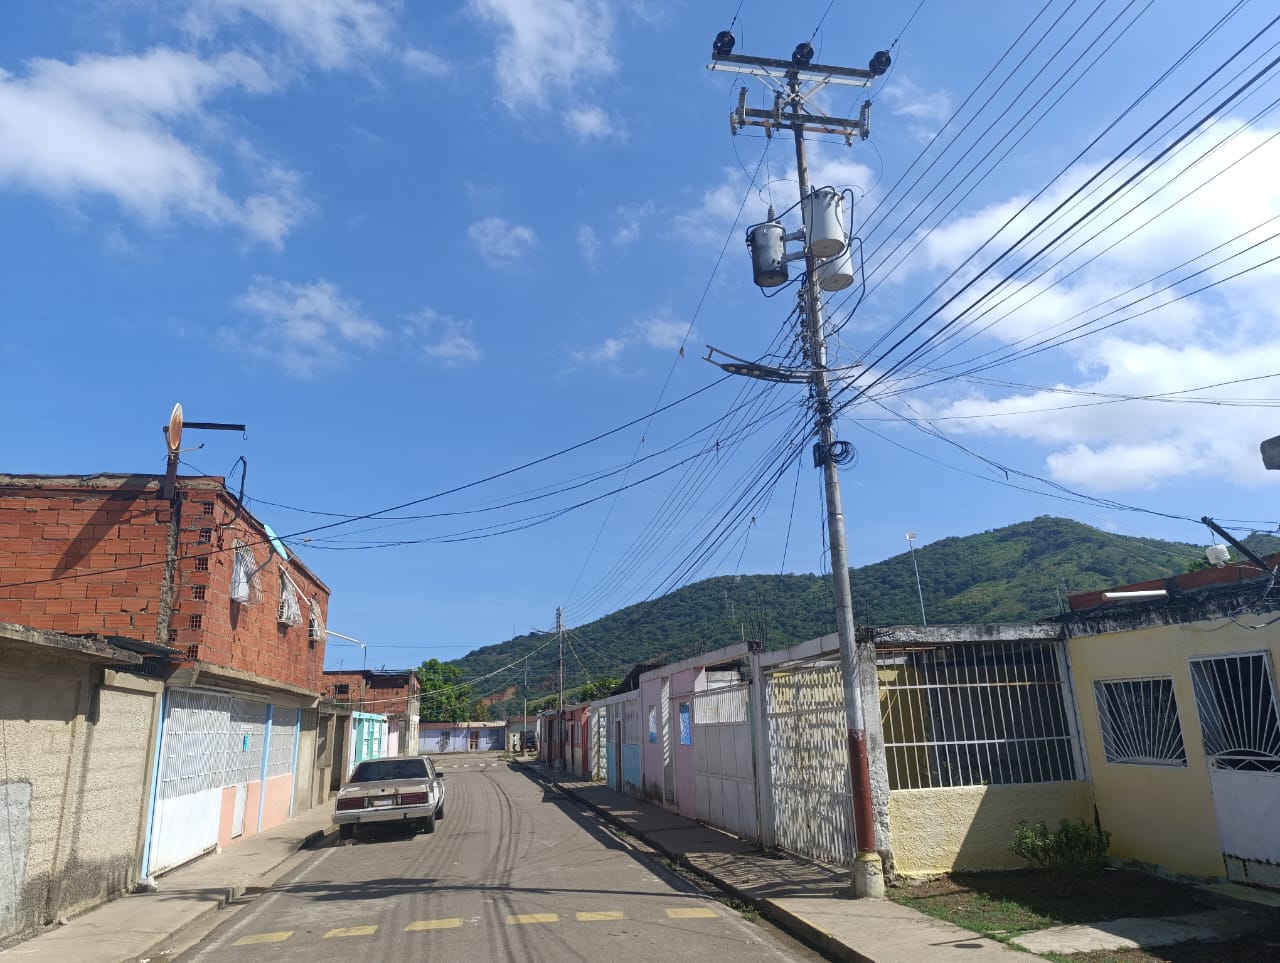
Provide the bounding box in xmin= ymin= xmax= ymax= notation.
xmin=0 ymin=640 xmax=161 ymax=945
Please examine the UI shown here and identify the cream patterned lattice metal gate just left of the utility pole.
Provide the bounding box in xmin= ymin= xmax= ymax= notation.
xmin=764 ymin=665 xmax=858 ymax=866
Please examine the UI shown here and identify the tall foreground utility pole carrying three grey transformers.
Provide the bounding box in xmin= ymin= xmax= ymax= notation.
xmin=708 ymin=31 xmax=890 ymax=896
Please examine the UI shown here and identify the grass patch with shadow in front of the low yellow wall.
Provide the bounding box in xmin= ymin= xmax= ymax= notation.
xmin=888 ymin=870 xmax=1210 ymax=941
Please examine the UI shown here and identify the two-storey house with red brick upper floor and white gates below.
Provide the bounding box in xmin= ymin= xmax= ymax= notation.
xmin=0 ymin=474 xmax=329 ymax=876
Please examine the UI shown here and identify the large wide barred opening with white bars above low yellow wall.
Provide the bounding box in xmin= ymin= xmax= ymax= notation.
xmin=876 ymin=640 xmax=1080 ymax=789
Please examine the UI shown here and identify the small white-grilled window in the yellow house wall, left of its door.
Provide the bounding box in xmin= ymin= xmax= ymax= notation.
xmin=1093 ymin=677 xmax=1187 ymax=766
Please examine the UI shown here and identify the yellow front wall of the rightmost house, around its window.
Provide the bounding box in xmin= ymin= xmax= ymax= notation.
xmin=1069 ymin=619 xmax=1280 ymax=876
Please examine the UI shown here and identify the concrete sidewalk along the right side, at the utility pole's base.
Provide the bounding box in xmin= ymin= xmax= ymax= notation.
xmin=525 ymin=763 xmax=1028 ymax=963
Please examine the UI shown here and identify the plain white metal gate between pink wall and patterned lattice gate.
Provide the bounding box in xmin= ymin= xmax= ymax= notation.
xmin=694 ymin=685 xmax=759 ymax=839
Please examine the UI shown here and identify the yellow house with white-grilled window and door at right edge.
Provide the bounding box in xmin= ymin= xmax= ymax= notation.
xmin=1062 ymin=565 xmax=1280 ymax=886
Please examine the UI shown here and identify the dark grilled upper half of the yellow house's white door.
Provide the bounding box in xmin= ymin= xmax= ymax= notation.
xmin=1190 ymin=652 xmax=1280 ymax=772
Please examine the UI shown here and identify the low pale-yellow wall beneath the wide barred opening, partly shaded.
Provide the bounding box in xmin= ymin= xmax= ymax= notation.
xmin=888 ymin=782 xmax=1093 ymax=876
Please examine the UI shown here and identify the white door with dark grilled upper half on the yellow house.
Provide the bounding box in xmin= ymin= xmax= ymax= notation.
xmin=1190 ymin=652 xmax=1280 ymax=886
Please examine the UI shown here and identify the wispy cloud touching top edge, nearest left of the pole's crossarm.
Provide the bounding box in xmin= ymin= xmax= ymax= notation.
xmin=470 ymin=0 xmax=616 ymax=108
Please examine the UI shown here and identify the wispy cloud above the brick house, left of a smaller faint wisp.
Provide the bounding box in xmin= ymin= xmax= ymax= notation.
xmin=229 ymin=277 xmax=385 ymax=376
